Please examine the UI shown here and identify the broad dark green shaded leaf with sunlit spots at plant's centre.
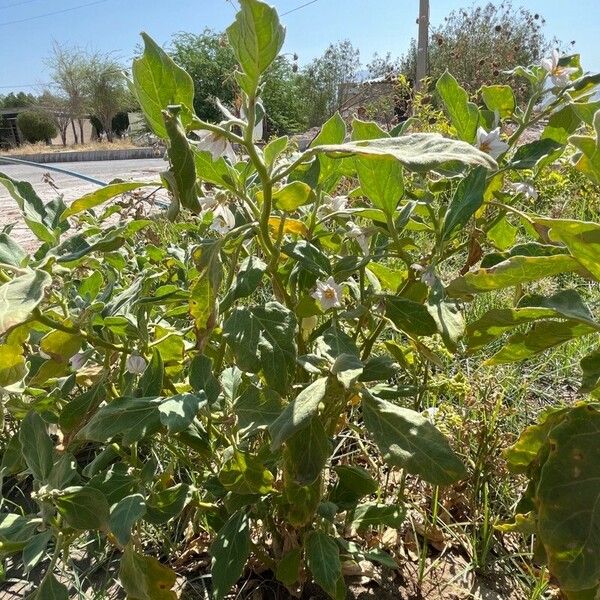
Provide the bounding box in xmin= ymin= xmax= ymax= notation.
xmin=223 ymin=302 xmax=296 ymax=394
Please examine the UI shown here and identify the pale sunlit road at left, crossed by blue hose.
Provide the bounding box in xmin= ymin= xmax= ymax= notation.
xmin=0 ymin=159 xmax=167 ymax=246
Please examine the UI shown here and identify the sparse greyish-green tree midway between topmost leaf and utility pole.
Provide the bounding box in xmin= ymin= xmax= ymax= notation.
xmin=302 ymin=40 xmax=360 ymax=127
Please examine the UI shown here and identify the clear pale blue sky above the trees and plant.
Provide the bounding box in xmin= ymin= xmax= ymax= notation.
xmin=0 ymin=0 xmax=600 ymax=94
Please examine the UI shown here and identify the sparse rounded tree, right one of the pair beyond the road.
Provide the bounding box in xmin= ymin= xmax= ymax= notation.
xmin=85 ymin=54 xmax=130 ymax=142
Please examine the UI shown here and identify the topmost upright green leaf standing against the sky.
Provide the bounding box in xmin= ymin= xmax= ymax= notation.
xmin=227 ymin=0 xmax=285 ymax=98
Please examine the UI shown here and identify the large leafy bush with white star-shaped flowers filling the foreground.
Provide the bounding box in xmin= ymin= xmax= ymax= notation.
xmin=0 ymin=0 xmax=600 ymax=600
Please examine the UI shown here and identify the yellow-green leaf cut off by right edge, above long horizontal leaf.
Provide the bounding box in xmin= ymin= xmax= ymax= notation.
xmin=536 ymin=218 xmax=600 ymax=281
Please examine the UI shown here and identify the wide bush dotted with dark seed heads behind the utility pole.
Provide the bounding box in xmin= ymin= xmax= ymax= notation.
xmin=403 ymin=0 xmax=551 ymax=92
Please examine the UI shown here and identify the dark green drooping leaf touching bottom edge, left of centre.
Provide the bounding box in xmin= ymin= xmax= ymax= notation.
xmin=210 ymin=511 xmax=250 ymax=600
